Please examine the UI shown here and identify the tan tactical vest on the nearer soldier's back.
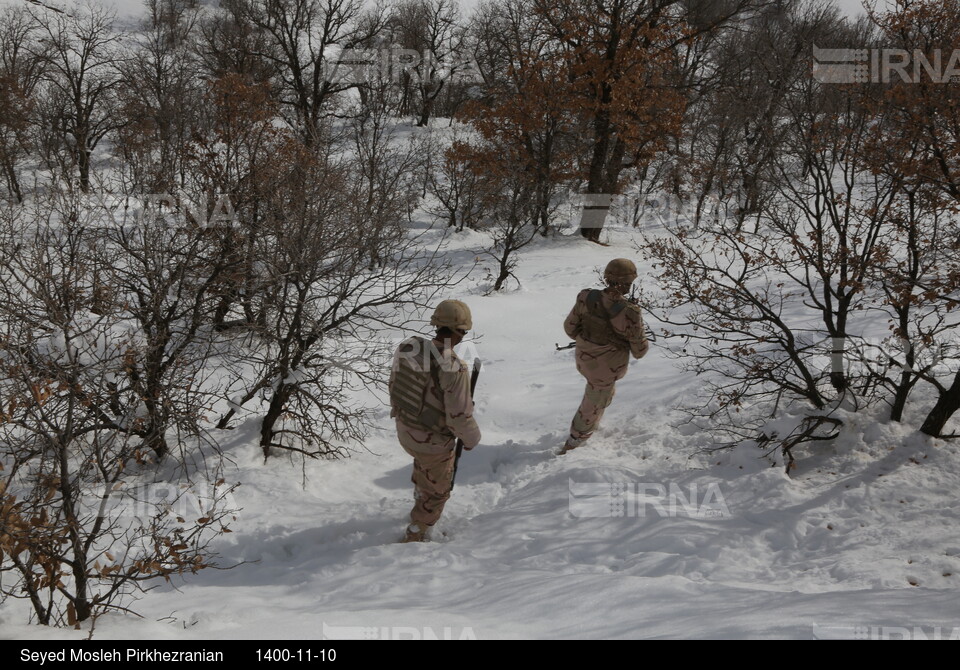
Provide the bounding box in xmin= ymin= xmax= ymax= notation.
xmin=390 ymin=337 xmax=449 ymax=433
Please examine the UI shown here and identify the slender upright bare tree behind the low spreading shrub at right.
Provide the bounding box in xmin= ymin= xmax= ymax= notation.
xmin=767 ymin=53 xmax=900 ymax=400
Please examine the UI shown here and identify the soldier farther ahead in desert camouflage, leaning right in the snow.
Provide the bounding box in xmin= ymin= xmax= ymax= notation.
xmin=560 ymin=258 xmax=650 ymax=454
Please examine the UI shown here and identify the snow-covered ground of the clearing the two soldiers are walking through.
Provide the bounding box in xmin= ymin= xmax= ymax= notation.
xmin=0 ymin=219 xmax=960 ymax=639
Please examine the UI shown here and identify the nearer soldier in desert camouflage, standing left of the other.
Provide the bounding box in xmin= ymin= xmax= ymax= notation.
xmin=390 ymin=300 xmax=480 ymax=542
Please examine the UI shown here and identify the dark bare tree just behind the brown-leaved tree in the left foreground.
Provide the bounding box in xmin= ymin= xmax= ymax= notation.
xmin=97 ymin=198 xmax=236 ymax=460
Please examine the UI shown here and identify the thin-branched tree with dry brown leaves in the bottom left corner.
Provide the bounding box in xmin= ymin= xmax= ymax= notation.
xmin=0 ymin=200 xmax=230 ymax=625
